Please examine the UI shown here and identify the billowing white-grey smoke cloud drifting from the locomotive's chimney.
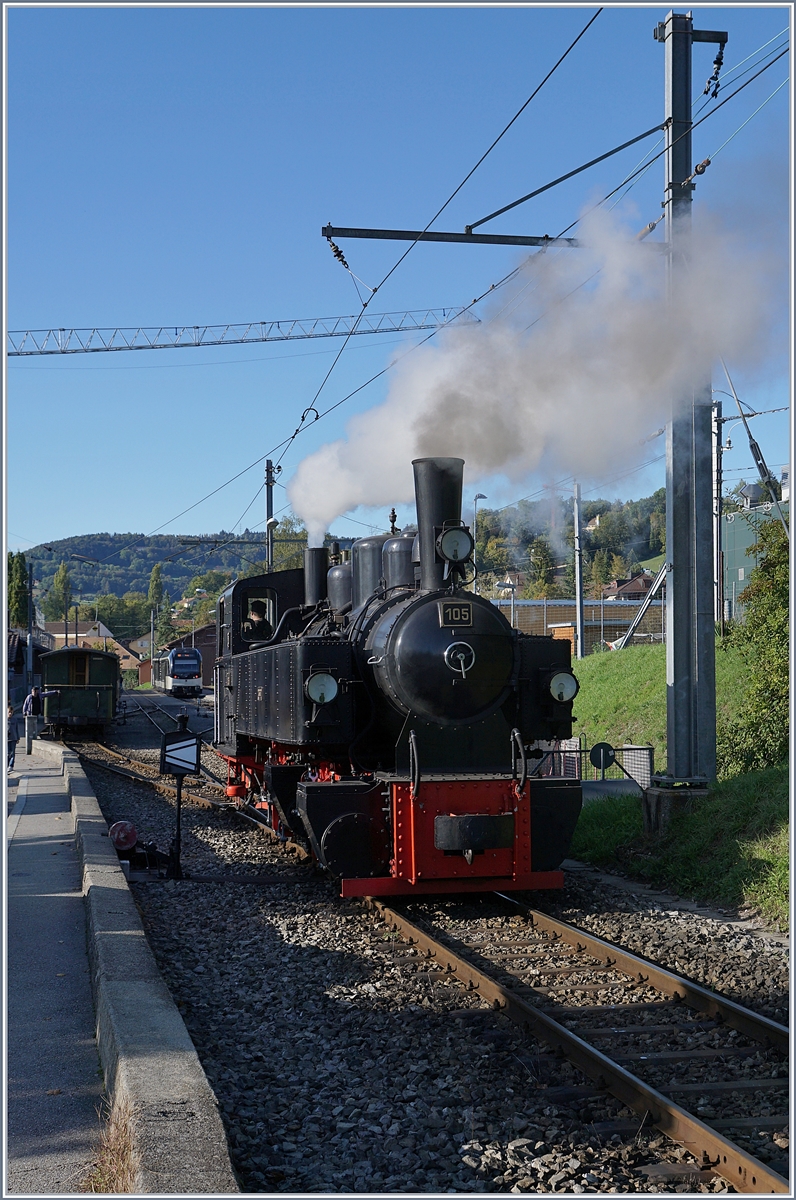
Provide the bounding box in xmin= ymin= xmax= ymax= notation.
xmin=288 ymin=212 xmax=774 ymax=545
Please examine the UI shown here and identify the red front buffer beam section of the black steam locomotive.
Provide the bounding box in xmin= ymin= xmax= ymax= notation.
xmin=333 ymin=774 xmax=581 ymax=896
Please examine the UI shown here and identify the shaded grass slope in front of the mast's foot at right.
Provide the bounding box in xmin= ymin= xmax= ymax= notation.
xmin=570 ymin=764 xmax=789 ymax=929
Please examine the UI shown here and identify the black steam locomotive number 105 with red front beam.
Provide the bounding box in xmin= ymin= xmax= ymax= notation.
xmin=215 ymin=458 xmax=581 ymax=895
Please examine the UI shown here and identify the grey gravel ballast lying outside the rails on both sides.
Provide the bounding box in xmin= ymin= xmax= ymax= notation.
xmin=86 ymin=767 xmax=786 ymax=1193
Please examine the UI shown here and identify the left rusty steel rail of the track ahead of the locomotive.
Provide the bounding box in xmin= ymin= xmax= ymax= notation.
xmin=365 ymin=896 xmax=790 ymax=1195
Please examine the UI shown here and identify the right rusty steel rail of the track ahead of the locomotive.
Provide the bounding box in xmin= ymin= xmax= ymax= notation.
xmin=496 ymin=892 xmax=790 ymax=1054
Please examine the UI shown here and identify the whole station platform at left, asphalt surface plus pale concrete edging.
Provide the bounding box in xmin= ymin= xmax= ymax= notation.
xmin=1 ymin=739 xmax=239 ymax=1196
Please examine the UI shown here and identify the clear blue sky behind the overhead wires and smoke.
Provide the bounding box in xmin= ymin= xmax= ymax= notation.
xmin=7 ymin=5 xmax=790 ymax=550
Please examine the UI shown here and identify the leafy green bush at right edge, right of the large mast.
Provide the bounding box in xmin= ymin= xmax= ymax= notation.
xmin=717 ymin=521 xmax=790 ymax=775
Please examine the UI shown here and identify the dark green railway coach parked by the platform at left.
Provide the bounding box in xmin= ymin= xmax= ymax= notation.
xmin=41 ymin=646 xmax=121 ymax=737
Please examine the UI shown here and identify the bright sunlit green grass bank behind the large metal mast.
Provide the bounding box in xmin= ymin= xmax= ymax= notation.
xmin=574 ymin=644 xmax=746 ymax=770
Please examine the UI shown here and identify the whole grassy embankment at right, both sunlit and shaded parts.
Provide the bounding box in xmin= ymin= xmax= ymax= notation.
xmin=570 ymin=646 xmax=789 ymax=928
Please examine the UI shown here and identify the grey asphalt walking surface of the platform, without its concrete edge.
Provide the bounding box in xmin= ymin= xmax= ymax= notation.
xmin=2 ymin=740 xmax=103 ymax=1195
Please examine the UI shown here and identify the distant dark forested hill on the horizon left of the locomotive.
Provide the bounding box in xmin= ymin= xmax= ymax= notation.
xmin=25 ymin=530 xmax=273 ymax=599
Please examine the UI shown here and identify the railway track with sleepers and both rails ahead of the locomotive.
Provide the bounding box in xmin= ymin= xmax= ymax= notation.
xmin=366 ymin=896 xmax=790 ymax=1194
